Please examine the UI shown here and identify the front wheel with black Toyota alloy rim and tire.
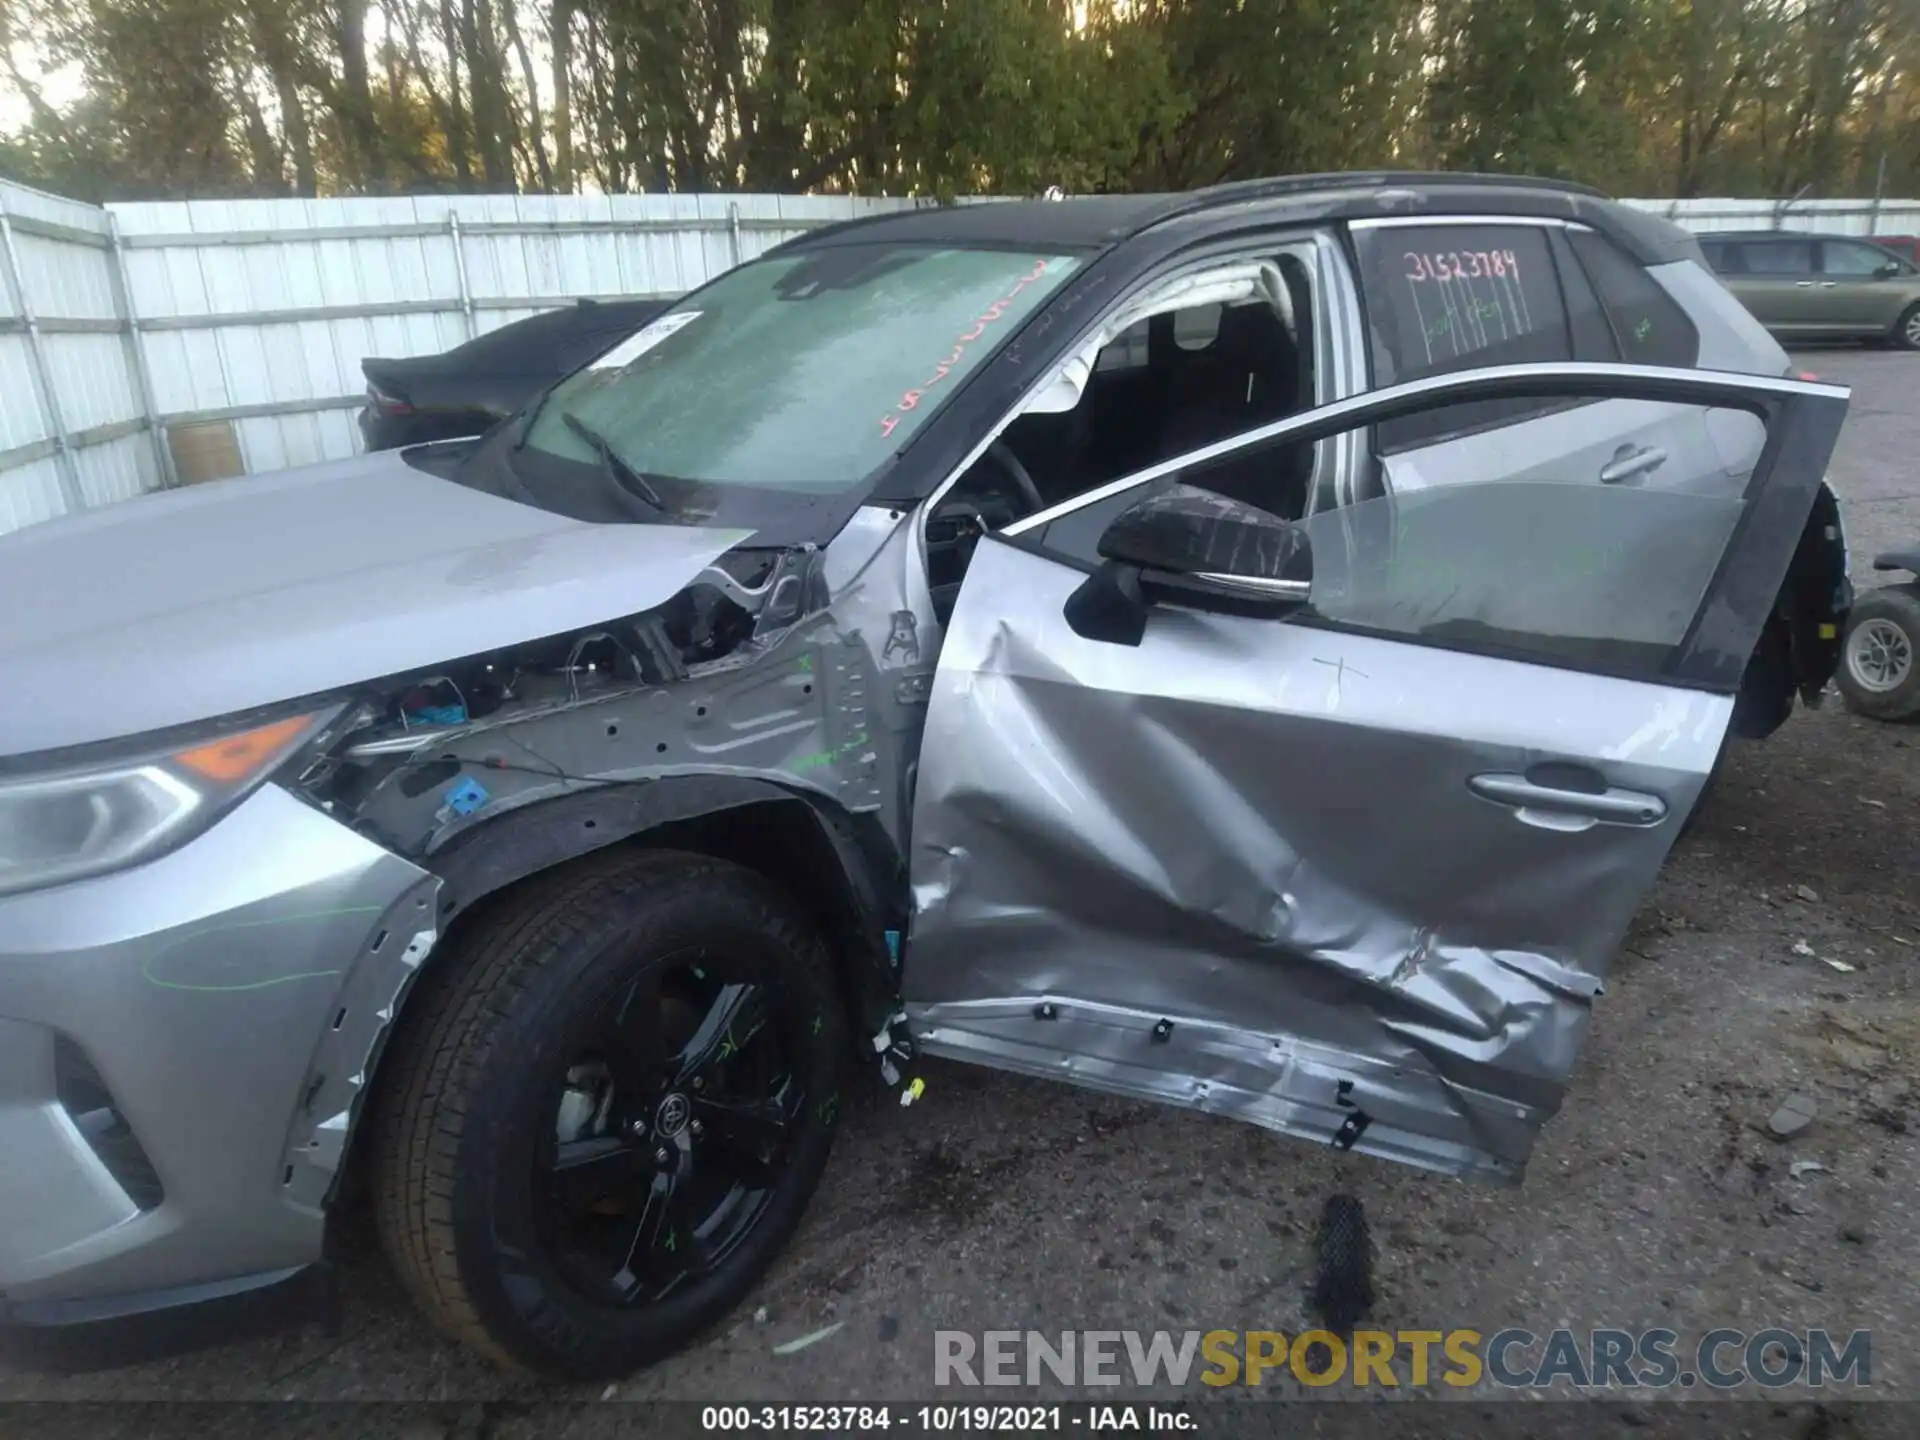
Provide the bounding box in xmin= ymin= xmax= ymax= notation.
xmin=372 ymin=852 xmax=847 ymax=1379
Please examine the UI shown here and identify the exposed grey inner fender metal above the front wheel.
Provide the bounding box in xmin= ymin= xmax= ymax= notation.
xmin=317 ymin=507 xmax=939 ymax=856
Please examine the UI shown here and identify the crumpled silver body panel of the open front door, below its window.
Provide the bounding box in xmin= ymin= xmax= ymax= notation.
xmin=904 ymin=540 xmax=1732 ymax=1179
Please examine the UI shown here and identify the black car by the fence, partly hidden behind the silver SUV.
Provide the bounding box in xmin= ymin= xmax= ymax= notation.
xmin=359 ymin=300 xmax=668 ymax=449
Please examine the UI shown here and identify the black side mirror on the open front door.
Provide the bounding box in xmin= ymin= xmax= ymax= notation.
xmin=1066 ymin=486 xmax=1313 ymax=645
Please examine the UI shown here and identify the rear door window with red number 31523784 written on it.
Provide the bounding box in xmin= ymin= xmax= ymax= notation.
xmin=1356 ymin=225 xmax=1574 ymax=455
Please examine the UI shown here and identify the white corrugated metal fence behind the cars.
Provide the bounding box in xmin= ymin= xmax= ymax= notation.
xmin=0 ymin=182 xmax=1920 ymax=532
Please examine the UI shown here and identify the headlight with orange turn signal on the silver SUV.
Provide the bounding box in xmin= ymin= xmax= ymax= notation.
xmin=0 ymin=712 xmax=332 ymax=895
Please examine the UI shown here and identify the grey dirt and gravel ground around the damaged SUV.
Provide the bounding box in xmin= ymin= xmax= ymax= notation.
xmin=0 ymin=351 xmax=1920 ymax=1434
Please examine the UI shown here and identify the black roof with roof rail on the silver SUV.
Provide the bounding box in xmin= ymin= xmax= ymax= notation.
xmin=778 ymin=171 xmax=1692 ymax=263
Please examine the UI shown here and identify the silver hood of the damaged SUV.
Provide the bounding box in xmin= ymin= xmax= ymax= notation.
xmin=0 ymin=453 xmax=753 ymax=756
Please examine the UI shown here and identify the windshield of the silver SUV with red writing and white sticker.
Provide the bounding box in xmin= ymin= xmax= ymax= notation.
xmin=526 ymin=244 xmax=1077 ymax=503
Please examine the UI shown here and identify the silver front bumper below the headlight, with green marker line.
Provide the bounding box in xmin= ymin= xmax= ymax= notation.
xmin=0 ymin=785 xmax=438 ymax=1351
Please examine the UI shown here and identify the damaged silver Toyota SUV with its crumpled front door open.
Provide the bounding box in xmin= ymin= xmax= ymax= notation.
xmin=0 ymin=175 xmax=1849 ymax=1375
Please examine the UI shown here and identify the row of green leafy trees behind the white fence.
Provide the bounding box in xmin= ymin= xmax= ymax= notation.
xmin=0 ymin=0 xmax=1920 ymax=196
